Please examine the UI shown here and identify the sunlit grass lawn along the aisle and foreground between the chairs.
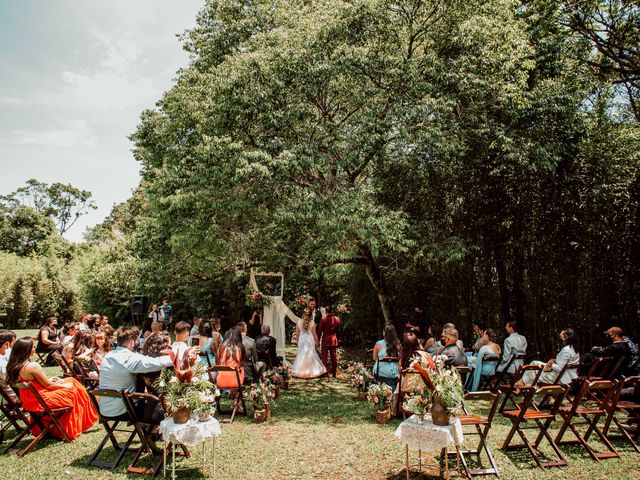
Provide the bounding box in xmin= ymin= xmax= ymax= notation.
xmin=0 ymin=336 xmax=640 ymax=480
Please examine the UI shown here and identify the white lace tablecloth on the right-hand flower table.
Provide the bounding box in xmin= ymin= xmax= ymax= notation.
xmin=396 ymin=415 xmax=463 ymax=452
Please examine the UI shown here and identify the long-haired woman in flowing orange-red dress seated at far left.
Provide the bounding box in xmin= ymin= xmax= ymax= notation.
xmin=7 ymin=337 xmax=98 ymax=438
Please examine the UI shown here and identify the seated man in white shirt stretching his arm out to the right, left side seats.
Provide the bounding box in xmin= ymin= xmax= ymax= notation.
xmin=98 ymin=327 xmax=174 ymax=417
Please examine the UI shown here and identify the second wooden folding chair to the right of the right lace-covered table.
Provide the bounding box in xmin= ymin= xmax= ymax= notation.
xmin=501 ymin=385 xmax=568 ymax=468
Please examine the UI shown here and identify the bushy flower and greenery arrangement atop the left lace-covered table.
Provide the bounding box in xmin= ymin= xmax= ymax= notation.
xmin=155 ymin=362 xmax=220 ymax=420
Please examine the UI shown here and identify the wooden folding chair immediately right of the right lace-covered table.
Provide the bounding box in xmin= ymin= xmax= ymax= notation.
xmin=448 ymin=391 xmax=500 ymax=478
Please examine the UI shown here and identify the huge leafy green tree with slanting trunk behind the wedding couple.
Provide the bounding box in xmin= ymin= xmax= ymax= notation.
xmin=133 ymin=0 xmax=533 ymax=322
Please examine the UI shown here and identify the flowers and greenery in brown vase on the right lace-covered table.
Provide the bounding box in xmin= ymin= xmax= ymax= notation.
xmin=407 ymin=353 xmax=464 ymax=425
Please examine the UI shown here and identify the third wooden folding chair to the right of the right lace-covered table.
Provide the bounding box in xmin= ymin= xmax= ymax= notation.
xmin=555 ymin=380 xmax=620 ymax=460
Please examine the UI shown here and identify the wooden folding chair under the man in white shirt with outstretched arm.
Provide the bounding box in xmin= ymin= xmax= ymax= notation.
xmin=87 ymin=388 xmax=138 ymax=470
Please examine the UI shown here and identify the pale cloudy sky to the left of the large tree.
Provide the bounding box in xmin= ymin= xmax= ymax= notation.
xmin=0 ymin=0 xmax=204 ymax=241
